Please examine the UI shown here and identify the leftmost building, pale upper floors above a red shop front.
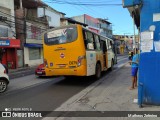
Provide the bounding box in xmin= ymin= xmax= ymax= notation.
xmin=0 ymin=0 xmax=20 ymax=69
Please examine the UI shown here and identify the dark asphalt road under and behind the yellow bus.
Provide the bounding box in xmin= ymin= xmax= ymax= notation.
xmin=0 ymin=57 xmax=127 ymax=119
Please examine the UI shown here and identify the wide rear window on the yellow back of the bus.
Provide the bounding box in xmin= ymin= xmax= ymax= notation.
xmin=44 ymin=26 xmax=78 ymax=45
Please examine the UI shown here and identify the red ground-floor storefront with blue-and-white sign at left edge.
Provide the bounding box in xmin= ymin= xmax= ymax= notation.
xmin=0 ymin=39 xmax=20 ymax=69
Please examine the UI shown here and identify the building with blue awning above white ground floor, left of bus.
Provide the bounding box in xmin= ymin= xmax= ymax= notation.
xmin=14 ymin=0 xmax=48 ymax=67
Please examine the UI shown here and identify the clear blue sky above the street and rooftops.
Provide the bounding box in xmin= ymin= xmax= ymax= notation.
xmin=42 ymin=0 xmax=137 ymax=35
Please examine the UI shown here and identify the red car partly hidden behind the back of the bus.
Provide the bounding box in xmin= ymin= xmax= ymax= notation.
xmin=35 ymin=64 xmax=46 ymax=77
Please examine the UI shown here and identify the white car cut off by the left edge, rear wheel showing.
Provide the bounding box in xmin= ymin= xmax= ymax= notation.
xmin=0 ymin=63 xmax=9 ymax=93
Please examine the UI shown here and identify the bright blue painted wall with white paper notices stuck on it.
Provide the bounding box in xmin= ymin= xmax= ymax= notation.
xmin=138 ymin=0 xmax=160 ymax=105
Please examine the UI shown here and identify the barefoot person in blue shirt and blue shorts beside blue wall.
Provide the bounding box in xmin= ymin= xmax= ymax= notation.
xmin=129 ymin=48 xmax=139 ymax=90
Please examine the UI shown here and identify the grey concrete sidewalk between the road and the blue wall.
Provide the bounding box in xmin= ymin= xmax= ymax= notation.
xmin=42 ymin=64 xmax=159 ymax=120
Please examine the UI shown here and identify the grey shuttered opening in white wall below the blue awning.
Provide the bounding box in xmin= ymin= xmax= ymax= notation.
xmin=29 ymin=48 xmax=41 ymax=60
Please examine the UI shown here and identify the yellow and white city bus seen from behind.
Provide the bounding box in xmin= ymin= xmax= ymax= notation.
xmin=43 ymin=25 xmax=115 ymax=78
